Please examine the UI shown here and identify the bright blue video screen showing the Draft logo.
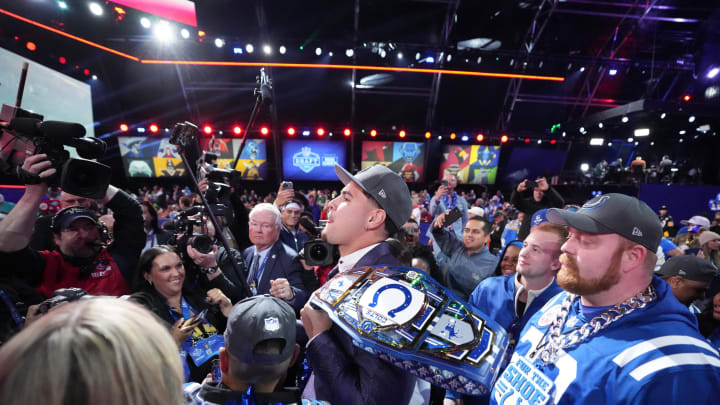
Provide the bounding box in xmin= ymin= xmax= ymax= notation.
xmin=282 ymin=139 xmax=345 ymax=181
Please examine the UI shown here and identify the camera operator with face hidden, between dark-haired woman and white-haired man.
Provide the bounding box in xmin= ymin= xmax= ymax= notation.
xmin=171 ymin=208 xmax=246 ymax=303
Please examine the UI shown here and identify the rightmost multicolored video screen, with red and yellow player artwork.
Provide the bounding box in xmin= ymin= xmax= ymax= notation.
xmin=440 ymin=145 xmax=500 ymax=184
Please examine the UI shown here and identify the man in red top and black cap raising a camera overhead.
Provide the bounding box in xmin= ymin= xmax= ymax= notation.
xmin=0 ymin=154 xmax=145 ymax=296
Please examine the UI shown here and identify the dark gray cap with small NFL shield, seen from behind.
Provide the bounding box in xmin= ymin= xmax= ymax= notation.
xmin=225 ymin=294 xmax=295 ymax=365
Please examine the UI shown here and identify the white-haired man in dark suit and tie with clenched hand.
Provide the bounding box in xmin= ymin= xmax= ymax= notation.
xmin=243 ymin=203 xmax=307 ymax=311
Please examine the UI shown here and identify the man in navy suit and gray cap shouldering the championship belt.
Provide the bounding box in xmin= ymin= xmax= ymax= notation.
xmin=300 ymin=164 xmax=415 ymax=405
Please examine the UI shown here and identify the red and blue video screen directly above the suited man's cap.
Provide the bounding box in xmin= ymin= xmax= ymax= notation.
xmin=360 ymin=141 xmax=425 ymax=182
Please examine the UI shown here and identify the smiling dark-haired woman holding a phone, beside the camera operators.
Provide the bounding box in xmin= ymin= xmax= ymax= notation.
xmin=130 ymin=245 xmax=232 ymax=382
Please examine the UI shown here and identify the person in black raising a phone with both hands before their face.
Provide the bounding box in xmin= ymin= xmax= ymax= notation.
xmin=510 ymin=177 xmax=565 ymax=240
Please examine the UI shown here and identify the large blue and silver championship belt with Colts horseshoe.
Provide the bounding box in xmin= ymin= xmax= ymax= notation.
xmin=310 ymin=266 xmax=509 ymax=395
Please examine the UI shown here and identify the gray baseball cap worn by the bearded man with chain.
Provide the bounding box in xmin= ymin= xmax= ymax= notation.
xmin=547 ymin=193 xmax=663 ymax=253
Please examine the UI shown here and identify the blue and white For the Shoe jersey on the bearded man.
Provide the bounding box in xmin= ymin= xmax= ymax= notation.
xmin=490 ymin=277 xmax=720 ymax=405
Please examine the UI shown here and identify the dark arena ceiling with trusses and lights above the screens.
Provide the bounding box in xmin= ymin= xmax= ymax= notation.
xmin=0 ymin=0 xmax=720 ymax=144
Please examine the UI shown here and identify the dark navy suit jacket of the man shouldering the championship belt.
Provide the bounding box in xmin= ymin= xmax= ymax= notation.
xmin=307 ymin=242 xmax=415 ymax=405
